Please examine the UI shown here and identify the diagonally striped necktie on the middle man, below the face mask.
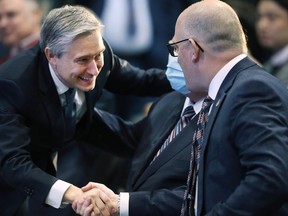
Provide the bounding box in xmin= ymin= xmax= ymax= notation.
xmin=151 ymin=106 xmax=195 ymax=163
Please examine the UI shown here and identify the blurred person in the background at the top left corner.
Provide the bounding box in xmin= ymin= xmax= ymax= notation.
xmin=0 ymin=0 xmax=42 ymax=64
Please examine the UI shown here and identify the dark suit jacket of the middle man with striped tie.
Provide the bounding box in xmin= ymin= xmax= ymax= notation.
xmin=93 ymin=92 xmax=197 ymax=216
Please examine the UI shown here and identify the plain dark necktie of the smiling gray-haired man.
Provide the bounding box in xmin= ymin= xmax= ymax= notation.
xmin=63 ymin=88 xmax=76 ymax=141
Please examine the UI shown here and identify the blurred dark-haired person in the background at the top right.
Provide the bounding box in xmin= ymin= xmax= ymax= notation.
xmin=256 ymin=0 xmax=288 ymax=86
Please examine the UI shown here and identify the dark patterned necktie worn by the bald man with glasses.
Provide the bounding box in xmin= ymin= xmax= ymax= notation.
xmin=181 ymin=96 xmax=213 ymax=216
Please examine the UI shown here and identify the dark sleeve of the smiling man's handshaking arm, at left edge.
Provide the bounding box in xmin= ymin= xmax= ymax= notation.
xmin=0 ymin=80 xmax=57 ymax=206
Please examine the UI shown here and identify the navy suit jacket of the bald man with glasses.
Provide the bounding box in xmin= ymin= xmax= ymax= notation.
xmin=197 ymin=58 xmax=288 ymax=216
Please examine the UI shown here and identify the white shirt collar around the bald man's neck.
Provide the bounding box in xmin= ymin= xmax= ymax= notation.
xmin=208 ymin=54 xmax=247 ymax=100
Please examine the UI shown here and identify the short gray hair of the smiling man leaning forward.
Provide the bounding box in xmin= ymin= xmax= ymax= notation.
xmin=39 ymin=5 xmax=104 ymax=57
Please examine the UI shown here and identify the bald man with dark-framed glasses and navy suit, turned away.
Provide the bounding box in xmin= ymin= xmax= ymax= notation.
xmin=170 ymin=0 xmax=288 ymax=216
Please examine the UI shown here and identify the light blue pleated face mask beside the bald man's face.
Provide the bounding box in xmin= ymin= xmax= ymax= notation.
xmin=166 ymin=55 xmax=190 ymax=95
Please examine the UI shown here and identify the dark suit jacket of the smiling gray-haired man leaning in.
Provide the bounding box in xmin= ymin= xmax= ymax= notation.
xmin=0 ymin=41 xmax=169 ymax=216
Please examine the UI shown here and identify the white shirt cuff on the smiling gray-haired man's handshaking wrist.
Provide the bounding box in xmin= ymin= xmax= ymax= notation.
xmin=45 ymin=180 xmax=71 ymax=208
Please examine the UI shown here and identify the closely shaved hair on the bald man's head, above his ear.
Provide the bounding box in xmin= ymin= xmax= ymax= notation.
xmin=184 ymin=1 xmax=247 ymax=53
